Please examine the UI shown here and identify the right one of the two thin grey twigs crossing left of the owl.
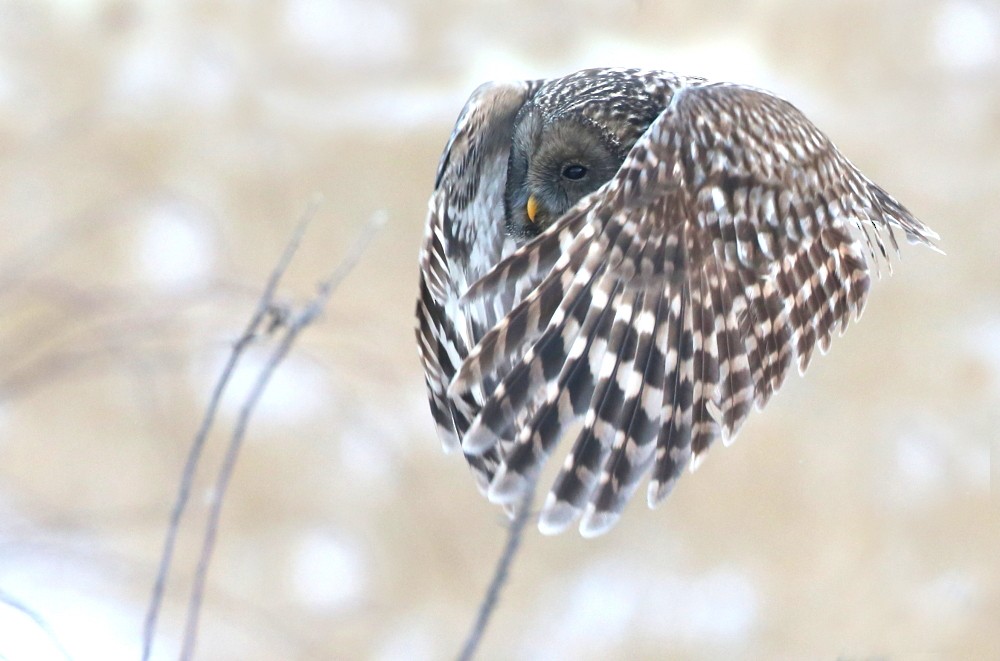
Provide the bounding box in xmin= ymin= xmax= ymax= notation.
xmin=181 ymin=214 xmax=385 ymax=660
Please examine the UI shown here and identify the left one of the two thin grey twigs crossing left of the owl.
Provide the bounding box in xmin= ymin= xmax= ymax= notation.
xmin=142 ymin=199 xmax=319 ymax=661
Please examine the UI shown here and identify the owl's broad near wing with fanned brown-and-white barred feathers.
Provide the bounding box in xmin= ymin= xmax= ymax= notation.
xmin=449 ymin=84 xmax=937 ymax=536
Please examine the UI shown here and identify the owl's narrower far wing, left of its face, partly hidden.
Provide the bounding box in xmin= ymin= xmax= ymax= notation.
xmin=416 ymin=76 xmax=542 ymax=488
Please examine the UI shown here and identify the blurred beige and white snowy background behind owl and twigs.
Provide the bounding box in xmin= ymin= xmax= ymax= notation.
xmin=0 ymin=0 xmax=1000 ymax=661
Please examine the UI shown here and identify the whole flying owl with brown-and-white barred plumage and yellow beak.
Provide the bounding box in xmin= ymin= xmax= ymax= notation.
xmin=417 ymin=69 xmax=937 ymax=536
